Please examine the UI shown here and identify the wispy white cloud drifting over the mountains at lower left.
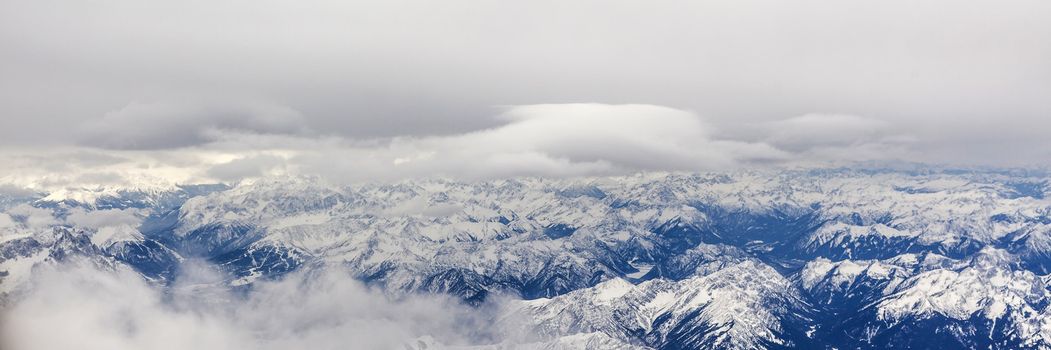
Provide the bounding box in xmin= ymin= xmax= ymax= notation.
xmin=0 ymin=262 xmax=517 ymax=350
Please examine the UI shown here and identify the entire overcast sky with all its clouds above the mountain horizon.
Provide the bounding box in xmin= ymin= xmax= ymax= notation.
xmin=0 ymin=0 xmax=1051 ymax=187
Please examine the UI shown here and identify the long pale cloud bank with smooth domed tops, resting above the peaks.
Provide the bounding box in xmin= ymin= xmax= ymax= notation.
xmin=0 ymin=104 xmax=931 ymax=187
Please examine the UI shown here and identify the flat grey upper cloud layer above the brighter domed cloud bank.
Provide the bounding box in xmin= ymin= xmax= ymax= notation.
xmin=0 ymin=0 xmax=1051 ymax=162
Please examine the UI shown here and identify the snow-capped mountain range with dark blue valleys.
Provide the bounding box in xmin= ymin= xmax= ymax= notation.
xmin=0 ymin=169 xmax=1051 ymax=349
